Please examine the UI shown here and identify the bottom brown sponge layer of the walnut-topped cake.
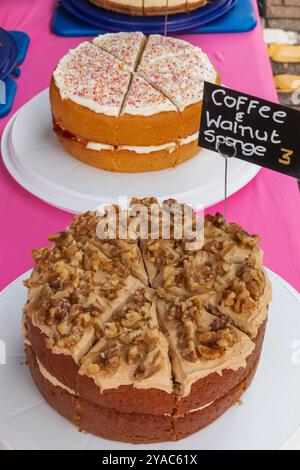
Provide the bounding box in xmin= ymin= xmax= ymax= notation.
xmin=26 ymin=346 xmax=258 ymax=444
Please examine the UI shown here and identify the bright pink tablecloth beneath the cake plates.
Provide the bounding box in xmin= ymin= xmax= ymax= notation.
xmin=0 ymin=0 xmax=300 ymax=290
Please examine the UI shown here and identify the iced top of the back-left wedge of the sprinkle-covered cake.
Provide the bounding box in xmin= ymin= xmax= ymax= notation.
xmin=93 ymin=32 xmax=146 ymax=71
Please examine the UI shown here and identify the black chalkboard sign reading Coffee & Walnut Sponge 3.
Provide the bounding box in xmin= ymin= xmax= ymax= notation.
xmin=199 ymin=82 xmax=300 ymax=179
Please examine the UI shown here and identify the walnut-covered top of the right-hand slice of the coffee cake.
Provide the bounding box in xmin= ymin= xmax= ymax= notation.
xmin=154 ymin=214 xmax=272 ymax=338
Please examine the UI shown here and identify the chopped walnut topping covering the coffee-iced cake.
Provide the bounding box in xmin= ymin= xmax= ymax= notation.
xmin=26 ymin=198 xmax=266 ymax=380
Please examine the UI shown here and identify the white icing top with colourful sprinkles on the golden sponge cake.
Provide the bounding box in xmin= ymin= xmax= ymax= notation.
xmin=54 ymin=33 xmax=216 ymax=116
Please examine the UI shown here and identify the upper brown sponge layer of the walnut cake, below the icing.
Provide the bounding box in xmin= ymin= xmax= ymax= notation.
xmin=26 ymin=318 xmax=266 ymax=415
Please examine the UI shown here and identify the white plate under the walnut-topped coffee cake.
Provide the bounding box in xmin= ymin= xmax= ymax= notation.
xmin=0 ymin=271 xmax=300 ymax=450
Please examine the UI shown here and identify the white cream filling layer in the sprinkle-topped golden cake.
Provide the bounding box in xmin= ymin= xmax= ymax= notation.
xmin=86 ymin=132 xmax=199 ymax=154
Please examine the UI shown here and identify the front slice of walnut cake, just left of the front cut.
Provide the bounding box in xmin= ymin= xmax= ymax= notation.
xmin=78 ymin=288 xmax=175 ymax=415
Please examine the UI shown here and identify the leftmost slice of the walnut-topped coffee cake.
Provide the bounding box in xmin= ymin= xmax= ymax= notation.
xmin=25 ymin=217 xmax=143 ymax=389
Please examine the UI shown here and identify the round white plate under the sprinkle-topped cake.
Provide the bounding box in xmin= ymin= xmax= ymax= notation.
xmin=2 ymin=90 xmax=260 ymax=212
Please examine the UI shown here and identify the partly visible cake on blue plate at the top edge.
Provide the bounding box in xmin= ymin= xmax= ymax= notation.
xmin=90 ymin=0 xmax=208 ymax=16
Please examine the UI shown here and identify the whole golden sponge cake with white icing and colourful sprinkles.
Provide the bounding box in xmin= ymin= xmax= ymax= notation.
xmin=50 ymin=32 xmax=219 ymax=172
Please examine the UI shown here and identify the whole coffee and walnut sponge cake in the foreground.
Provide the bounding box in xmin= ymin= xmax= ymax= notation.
xmin=23 ymin=198 xmax=271 ymax=443
